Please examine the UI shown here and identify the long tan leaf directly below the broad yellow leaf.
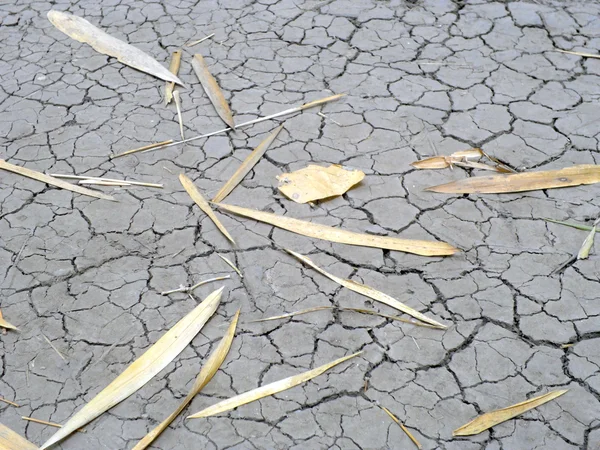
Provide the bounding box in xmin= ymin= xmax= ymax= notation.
xmin=215 ymin=203 xmax=458 ymax=256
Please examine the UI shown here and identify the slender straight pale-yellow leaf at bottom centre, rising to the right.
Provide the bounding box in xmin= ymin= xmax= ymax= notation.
xmin=187 ymin=352 xmax=362 ymax=419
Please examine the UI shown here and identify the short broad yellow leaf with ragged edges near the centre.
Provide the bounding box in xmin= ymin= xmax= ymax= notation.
xmin=277 ymin=164 xmax=365 ymax=203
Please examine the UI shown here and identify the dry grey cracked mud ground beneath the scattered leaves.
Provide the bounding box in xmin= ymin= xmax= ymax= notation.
xmin=0 ymin=0 xmax=600 ymax=450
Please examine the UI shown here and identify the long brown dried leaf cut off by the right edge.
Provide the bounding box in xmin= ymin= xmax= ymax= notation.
xmin=425 ymin=164 xmax=600 ymax=194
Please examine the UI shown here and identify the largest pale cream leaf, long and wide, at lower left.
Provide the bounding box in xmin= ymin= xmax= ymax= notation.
xmin=40 ymin=288 xmax=224 ymax=450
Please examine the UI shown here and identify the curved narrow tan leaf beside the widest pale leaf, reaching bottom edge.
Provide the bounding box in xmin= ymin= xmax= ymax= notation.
xmin=133 ymin=309 xmax=240 ymax=450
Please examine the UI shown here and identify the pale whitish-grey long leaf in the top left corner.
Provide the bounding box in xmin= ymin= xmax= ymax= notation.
xmin=48 ymin=10 xmax=183 ymax=86
